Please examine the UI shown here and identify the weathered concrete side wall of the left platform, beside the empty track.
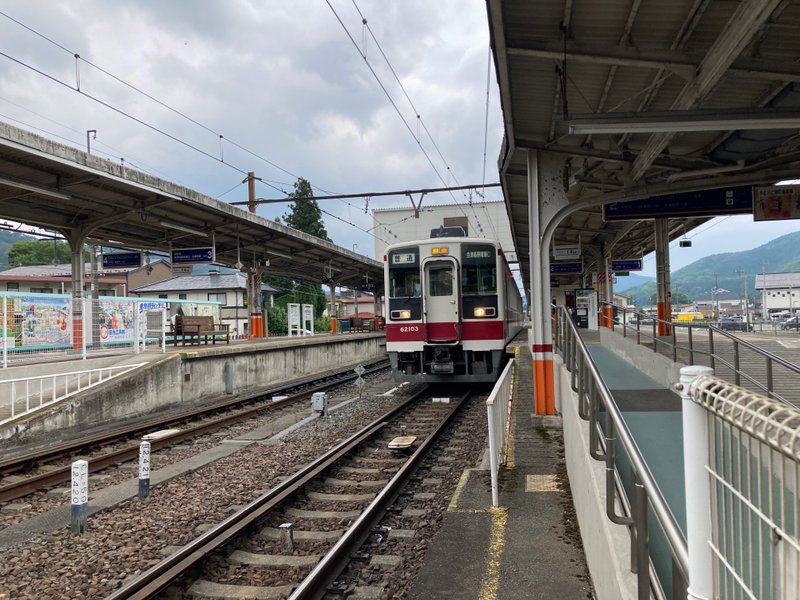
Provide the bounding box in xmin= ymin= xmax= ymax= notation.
xmin=0 ymin=334 xmax=386 ymax=447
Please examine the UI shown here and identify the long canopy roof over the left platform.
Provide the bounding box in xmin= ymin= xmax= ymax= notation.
xmin=0 ymin=123 xmax=383 ymax=287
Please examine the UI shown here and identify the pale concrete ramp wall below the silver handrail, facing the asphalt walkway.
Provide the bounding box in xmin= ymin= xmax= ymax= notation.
xmin=553 ymin=356 xmax=637 ymax=600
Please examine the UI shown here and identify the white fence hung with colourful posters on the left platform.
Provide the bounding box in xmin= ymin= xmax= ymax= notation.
xmin=0 ymin=292 xmax=220 ymax=368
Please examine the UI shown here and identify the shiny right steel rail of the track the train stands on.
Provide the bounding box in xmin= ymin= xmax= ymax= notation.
xmin=288 ymin=391 xmax=472 ymax=600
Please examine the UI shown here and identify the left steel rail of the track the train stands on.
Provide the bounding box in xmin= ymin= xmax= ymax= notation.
xmin=106 ymin=388 xmax=434 ymax=600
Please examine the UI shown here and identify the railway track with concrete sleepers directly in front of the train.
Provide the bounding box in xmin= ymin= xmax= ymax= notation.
xmin=108 ymin=390 xmax=482 ymax=600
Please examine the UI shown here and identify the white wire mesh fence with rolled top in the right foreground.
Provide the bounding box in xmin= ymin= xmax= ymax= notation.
xmin=687 ymin=375 xmax=800 ymax=600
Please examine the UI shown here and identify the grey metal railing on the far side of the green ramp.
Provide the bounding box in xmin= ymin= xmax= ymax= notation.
xmin=601 ymin=302 xmax=800 ymax=404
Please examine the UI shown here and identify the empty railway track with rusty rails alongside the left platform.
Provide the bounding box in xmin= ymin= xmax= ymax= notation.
xmin=0 ymin=361 xmax=388 ymax=502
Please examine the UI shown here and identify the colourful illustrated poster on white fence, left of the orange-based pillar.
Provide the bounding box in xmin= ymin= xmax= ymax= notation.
xmin=19 ymin=296 xmax=71 ymax=347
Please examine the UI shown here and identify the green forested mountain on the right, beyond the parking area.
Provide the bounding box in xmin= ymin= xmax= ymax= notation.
xmin=615 ymin=231 xmax=800 ymax=306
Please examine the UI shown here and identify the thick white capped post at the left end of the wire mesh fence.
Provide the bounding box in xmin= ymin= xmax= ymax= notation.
xmin=680 ymin=365 xmax=714 ymax=600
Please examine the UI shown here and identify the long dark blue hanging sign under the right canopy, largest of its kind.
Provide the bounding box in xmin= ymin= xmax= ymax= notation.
xmin=603 ymin=185 xmax=753 ymax=221
